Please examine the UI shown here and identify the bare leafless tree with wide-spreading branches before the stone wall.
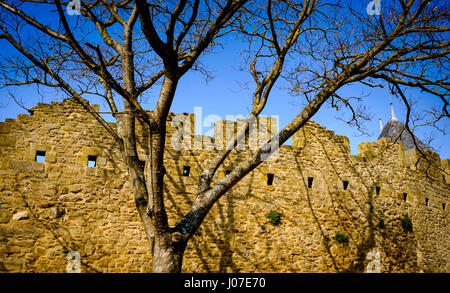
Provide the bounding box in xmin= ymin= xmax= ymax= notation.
xmin=0 ymin=0 xmax=449 ymax=272
